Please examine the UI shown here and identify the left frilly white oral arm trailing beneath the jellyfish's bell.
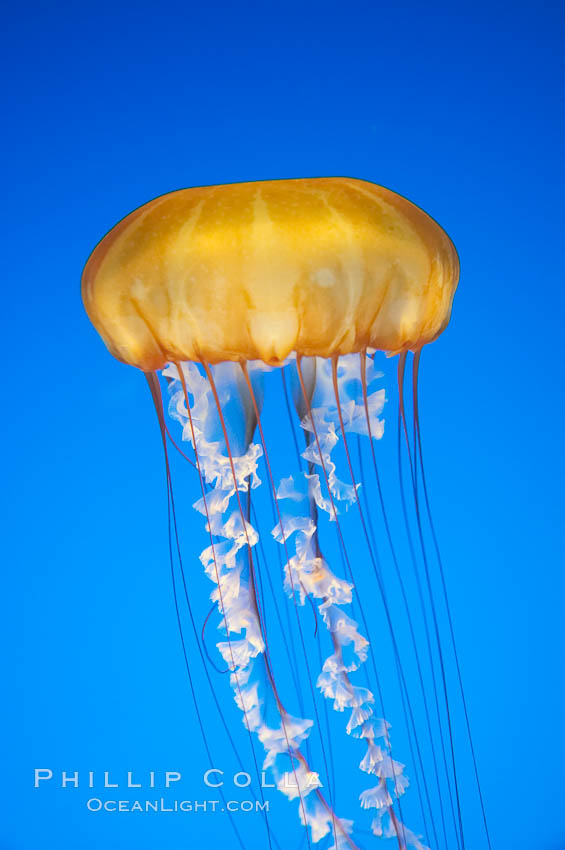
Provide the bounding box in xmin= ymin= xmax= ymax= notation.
xmin=164 ymin=363 xmax=356 ymax=850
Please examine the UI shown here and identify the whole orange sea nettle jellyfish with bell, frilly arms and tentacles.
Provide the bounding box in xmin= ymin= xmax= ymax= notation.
xmin=82 ymin=177 xmax=488 ymax=850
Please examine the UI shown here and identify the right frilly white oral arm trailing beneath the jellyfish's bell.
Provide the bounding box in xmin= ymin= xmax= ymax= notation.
xmin=272 ymin=357 xmax=423 ymax=850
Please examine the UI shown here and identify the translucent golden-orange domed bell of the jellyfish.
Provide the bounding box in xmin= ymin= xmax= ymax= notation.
xmin=82 ymin=177 xmax=459 ymax=372
